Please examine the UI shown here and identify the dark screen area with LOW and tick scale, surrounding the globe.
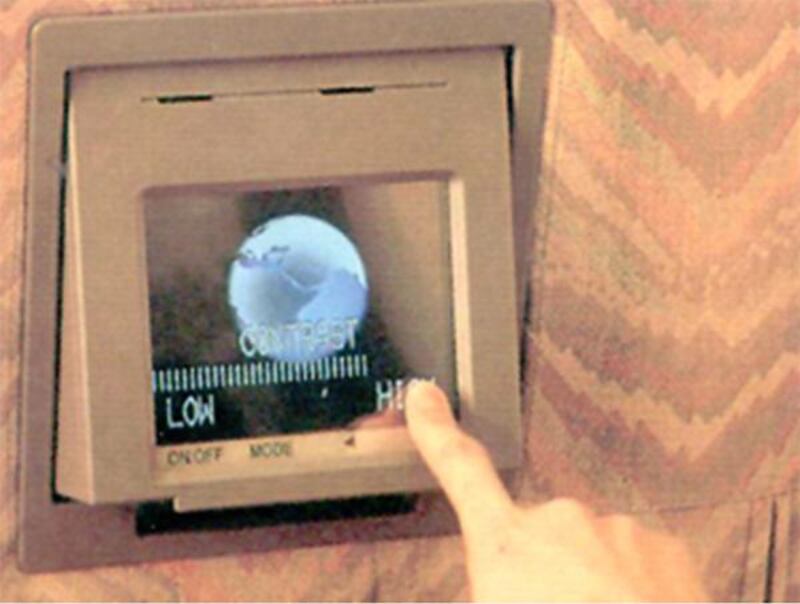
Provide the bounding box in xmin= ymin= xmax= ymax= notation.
xmin=145 ymin=183 xmax=455 ymax=445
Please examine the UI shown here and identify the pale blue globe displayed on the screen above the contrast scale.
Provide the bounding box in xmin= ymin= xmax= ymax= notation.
xmin=228 ymin=214 xmax=369 ymax=362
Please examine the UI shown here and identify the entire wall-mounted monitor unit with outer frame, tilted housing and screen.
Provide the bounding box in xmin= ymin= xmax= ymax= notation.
xmin=20 ymin=0 xmax=549 ymax=570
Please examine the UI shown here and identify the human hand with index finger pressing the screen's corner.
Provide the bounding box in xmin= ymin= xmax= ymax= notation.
xmin=405 ymin=382 xmax=708 ymax=601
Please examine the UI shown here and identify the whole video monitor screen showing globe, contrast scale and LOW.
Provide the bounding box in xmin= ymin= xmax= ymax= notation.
xmin=144 ymin=181 xmax=457 ymax=445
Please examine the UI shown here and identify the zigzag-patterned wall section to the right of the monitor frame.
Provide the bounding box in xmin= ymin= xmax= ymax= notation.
xmin=524 ymin=0 xmax=800 ymax=599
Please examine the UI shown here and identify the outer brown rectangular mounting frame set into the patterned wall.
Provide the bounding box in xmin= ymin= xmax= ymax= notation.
xmin=18 ymin=0 xmax=551 ymax=572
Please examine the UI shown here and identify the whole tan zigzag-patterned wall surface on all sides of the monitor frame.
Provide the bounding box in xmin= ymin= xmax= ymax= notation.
xmin=0 ymin=0 xmax=800 ymax=600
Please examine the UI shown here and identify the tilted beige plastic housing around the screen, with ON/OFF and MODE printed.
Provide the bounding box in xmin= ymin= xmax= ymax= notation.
xmin=56 ymin=49 xmax=520 ymax=510
